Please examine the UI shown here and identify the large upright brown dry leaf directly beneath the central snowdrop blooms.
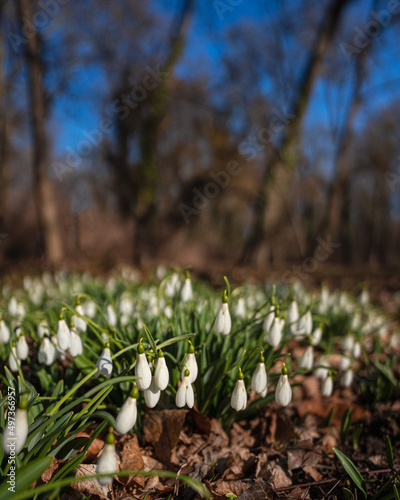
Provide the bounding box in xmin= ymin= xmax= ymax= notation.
xmin=143 ymin=410 xmax=188 ymax=463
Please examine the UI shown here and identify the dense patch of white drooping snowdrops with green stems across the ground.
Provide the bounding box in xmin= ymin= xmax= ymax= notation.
xmin=0 ymin=269 xmax=399 ymax=484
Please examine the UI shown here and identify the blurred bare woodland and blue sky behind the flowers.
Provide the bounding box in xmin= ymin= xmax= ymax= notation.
xmin=0 ymin=0 xmax=400 ymax=280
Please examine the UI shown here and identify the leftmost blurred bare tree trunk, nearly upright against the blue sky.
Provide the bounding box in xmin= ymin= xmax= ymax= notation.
xmin=18 ymin=0 xmax=64 ymax=266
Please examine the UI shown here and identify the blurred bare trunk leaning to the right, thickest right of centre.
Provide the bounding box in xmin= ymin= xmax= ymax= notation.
xmin=240 ymin=0 xmax=347 ymax=264
